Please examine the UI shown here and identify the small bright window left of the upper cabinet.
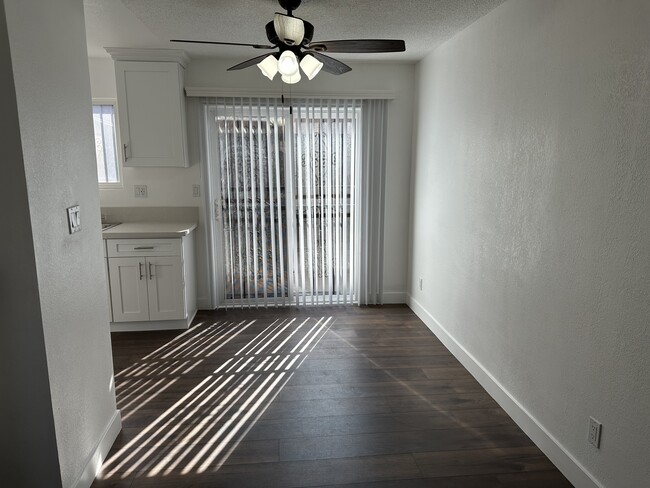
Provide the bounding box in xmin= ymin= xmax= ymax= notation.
xmin=93 ymin=100 xmax=120 ymax=187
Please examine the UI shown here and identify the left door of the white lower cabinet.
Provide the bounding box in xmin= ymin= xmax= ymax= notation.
xmin=108 ymin=258 xmax=149 ymax=322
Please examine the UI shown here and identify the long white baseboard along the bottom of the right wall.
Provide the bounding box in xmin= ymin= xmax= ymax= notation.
xmin=407 ymin=296 xmax=604 ymax=488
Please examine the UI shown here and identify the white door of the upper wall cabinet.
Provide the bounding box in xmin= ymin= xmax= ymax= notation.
xmin=115 ymin=61 xmax=187 ymax=167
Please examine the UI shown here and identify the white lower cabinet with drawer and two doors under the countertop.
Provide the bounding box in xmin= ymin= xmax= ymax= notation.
xmin=107 ymin=236 xmax=196 ymax=331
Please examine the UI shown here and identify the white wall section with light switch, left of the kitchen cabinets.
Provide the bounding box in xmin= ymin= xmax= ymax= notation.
xmin=0 ymin=0 xmax=119 ymax=487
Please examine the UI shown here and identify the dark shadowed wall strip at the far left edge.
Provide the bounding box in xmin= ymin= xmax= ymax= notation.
xmin=0 ymin=2 xmax=61 ymax=487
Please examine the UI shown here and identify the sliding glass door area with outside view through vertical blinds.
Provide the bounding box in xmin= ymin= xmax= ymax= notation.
xmin=213 ymin=98 xmax=361 ymax=306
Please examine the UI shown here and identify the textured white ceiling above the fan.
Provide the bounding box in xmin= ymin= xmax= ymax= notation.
xmin=84 ymin=0 xmax=504 ymax=62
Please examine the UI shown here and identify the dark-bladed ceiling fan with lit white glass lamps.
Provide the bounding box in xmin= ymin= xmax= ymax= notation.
xmin=171 ymin=0 xmax=406 ymax=84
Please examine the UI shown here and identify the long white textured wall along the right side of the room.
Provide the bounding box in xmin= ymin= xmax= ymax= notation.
xmin=409 ymin=0 xmax=650 ymax=488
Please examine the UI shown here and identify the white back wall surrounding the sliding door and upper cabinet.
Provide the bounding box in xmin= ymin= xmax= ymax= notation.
xmin=90 ymin=57 xmax=414 ymax=305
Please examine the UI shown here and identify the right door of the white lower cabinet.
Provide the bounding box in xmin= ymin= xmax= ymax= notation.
xmin=147 ymin=256 xmax=185 ymax=320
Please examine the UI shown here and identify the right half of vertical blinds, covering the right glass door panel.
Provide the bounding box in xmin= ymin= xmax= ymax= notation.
xmin=291 ymin=100 xmax=360 ymax=304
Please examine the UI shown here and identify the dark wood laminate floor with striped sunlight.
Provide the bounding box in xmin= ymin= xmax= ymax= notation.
xmin=93 ymin=306 xmax=571 ymax=488
